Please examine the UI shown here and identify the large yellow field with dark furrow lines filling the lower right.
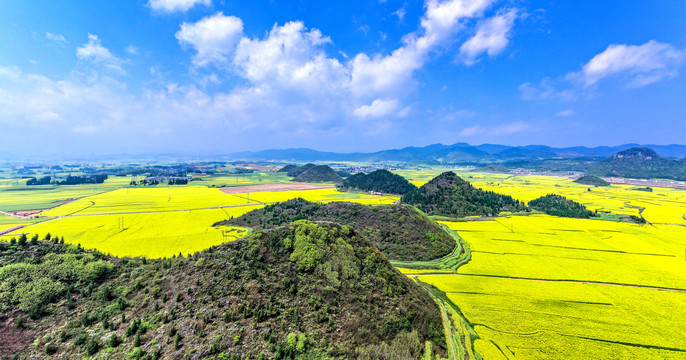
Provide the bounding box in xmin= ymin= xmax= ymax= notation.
xmin=416 ymin=215 xmax=686 ymax=359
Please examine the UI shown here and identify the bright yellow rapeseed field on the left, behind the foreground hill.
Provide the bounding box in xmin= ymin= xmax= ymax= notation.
xmin=6 ymin=186 xmax=399 ymax=258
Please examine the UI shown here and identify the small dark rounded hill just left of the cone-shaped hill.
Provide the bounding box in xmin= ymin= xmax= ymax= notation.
xmin=341 ymin=170 xmax=417 ymax=195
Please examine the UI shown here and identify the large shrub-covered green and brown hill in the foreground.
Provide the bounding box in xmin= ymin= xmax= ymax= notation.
xmin=0 ymin=221 xmax=445 ymax=359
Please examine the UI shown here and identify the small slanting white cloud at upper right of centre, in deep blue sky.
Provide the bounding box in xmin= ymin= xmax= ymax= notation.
xmin=460 ymin=10 xmax=517 ymax=65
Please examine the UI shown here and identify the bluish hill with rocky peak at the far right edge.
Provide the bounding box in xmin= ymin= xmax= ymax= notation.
xmin=588 ymin=147 xmax=686 ymax=180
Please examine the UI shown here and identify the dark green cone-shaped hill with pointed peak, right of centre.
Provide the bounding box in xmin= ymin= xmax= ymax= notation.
xmin=402 ymin=171 xmax=527 ymax=217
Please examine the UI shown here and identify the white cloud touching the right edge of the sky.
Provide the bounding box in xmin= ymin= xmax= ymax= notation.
xmin=568 ymin=40 xmax=684 ymax=87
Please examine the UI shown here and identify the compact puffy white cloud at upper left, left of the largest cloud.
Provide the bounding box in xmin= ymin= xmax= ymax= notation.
xmin=175 ymin=12 xmax=243 ymax=66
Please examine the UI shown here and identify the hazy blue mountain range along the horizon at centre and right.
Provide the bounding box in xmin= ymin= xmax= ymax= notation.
xmin=227 ymin=143 xmax=686 ymax=164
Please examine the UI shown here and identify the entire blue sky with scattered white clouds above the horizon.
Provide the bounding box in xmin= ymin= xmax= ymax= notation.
xmin=0 ymin=0 xmax=686 ymax=156
